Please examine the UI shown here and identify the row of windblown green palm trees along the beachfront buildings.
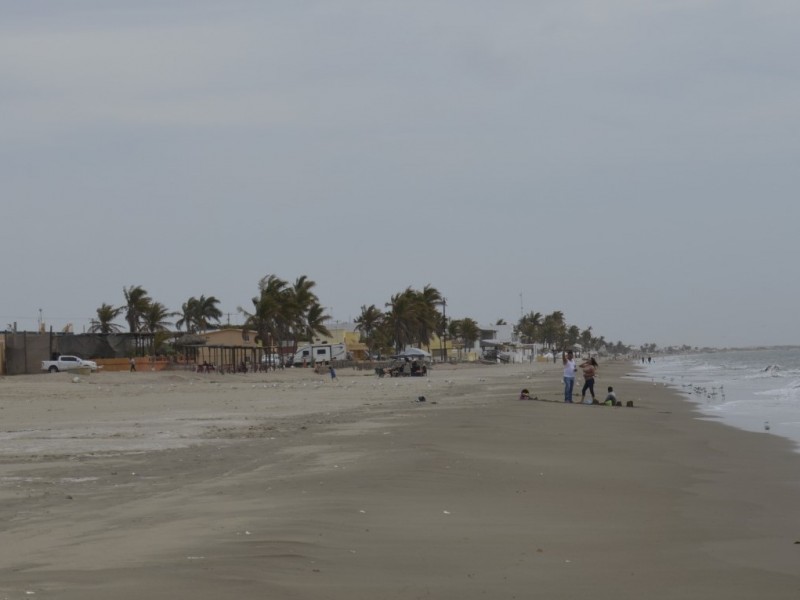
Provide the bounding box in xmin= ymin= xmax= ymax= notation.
xmin=90 ymin=275 xmax=630 ymax=355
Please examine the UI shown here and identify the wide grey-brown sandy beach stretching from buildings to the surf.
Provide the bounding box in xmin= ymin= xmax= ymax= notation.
xmin=0 ymin=362 xmax=800 ymax=600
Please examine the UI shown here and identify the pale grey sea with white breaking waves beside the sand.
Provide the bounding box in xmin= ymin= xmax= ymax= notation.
xmin=637 ymin=348 xmax=800 ymax=451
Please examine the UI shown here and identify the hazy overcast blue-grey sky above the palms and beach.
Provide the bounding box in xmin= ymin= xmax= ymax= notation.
xmin=0 ymin=0 xmax=800 ymax=347
